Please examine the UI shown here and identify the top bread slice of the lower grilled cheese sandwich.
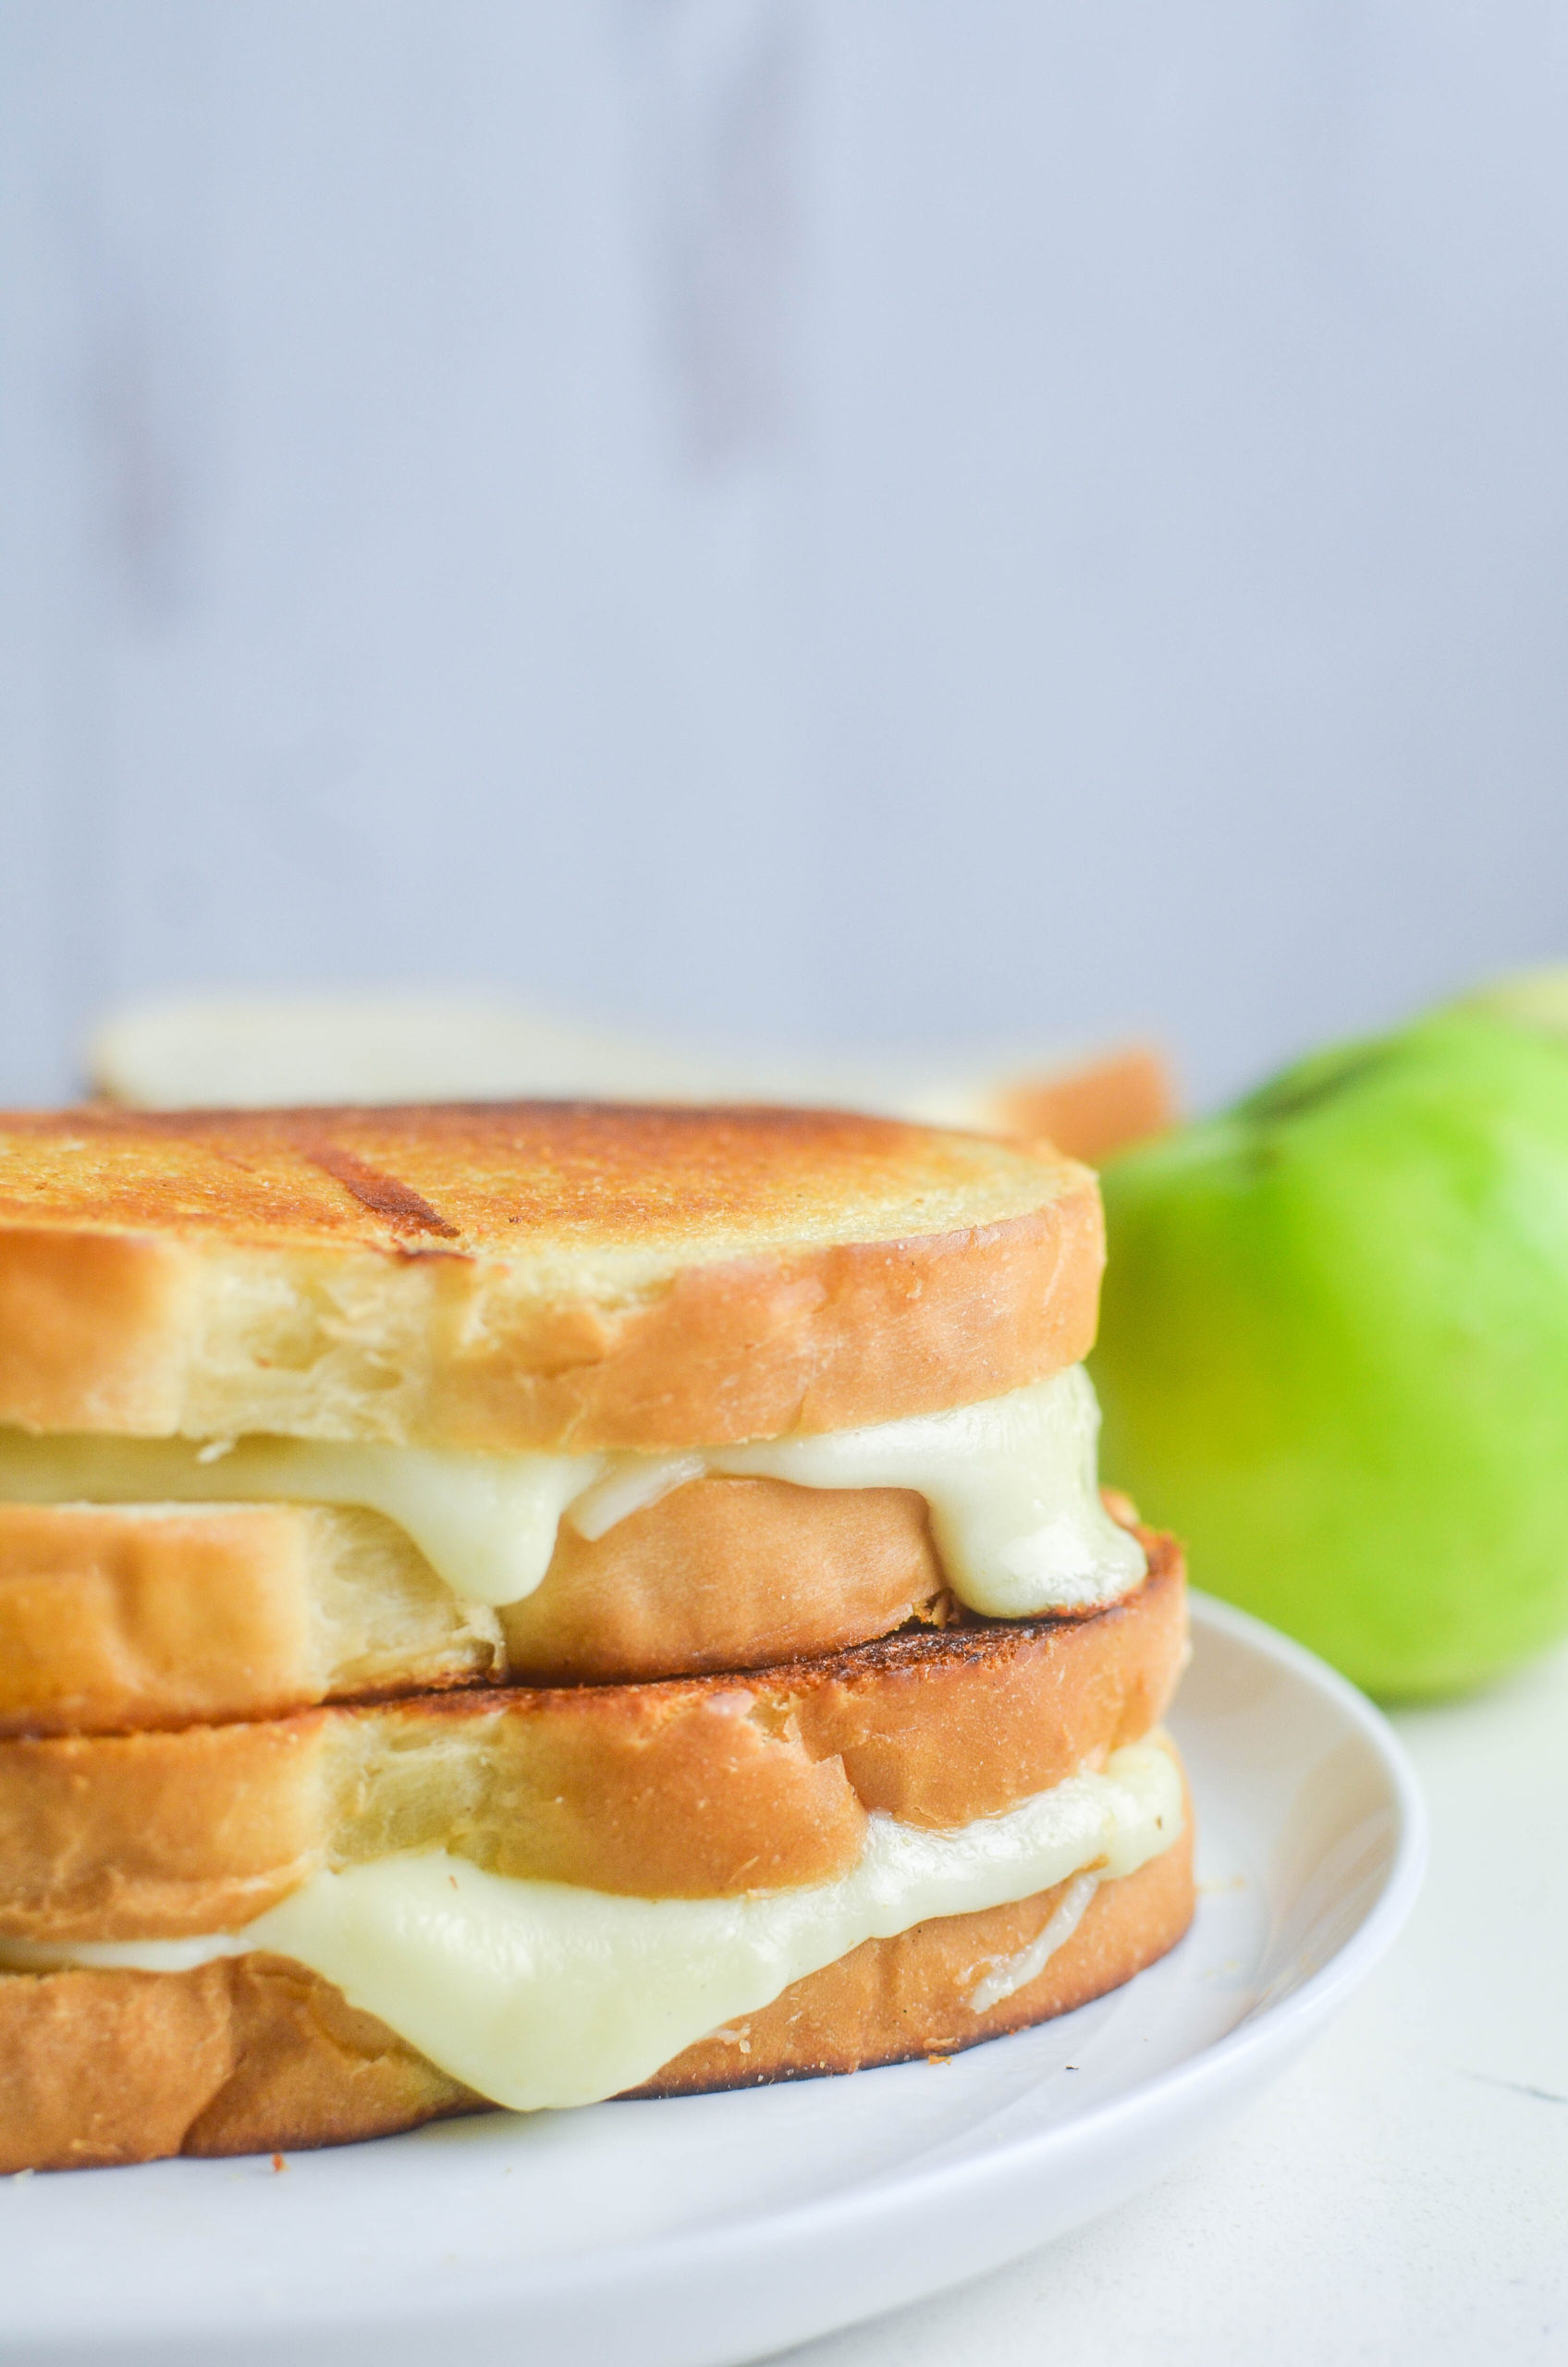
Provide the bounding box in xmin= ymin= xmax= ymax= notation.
xmin=0 ymin=1531 xmax=1187 ymax=1941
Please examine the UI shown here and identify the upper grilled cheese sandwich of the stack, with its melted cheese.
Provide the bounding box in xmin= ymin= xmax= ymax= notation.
xmin=0 ymin=1108 xmax=1142 ymax=1730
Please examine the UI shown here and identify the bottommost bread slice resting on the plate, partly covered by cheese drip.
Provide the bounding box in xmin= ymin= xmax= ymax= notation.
xmin=0 ymin=1832 xmax=1194 ymax=2173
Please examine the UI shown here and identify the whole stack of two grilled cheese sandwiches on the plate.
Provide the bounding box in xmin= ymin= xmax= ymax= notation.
xmin=0 ymin=1103 xmax=1192 ymax=2171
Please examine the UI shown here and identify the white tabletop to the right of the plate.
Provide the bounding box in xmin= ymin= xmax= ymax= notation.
xmin=789 ymin=1654 xmax=1568 ymax=2367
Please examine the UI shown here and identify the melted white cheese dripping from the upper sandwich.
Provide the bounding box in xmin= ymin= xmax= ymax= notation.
xmin=0 ymin=1366 xmax=1144 ymax=1619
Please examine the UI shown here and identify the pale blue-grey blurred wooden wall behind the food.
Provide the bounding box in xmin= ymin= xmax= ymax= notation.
xmin=0 ymin=0 xmax=1568 ymax=1096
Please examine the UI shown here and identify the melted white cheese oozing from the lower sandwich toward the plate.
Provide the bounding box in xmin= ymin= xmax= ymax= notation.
xmin=0 ymin=1737 xmax=1182 ymax=2112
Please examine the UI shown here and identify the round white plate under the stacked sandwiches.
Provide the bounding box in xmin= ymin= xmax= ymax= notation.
xmin=0 ymin=1598 xmax=1424 ymax=2367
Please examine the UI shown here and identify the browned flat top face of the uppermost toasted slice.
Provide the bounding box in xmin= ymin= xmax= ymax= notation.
xmin=0 ymin=1100 xmax=1078 ymax=1269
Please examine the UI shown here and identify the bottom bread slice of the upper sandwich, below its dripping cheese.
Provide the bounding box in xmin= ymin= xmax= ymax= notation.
xmin=0 ymin=1477 xmax=952 ymax=1735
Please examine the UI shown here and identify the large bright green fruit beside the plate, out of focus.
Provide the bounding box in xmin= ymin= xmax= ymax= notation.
xmin=1092 ymin=1009 xmax=1568 ymax=1698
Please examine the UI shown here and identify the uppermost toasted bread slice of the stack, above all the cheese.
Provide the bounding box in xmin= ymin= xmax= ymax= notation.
xmin=0 ymin=1103 xmax=1104 ymax=1451
